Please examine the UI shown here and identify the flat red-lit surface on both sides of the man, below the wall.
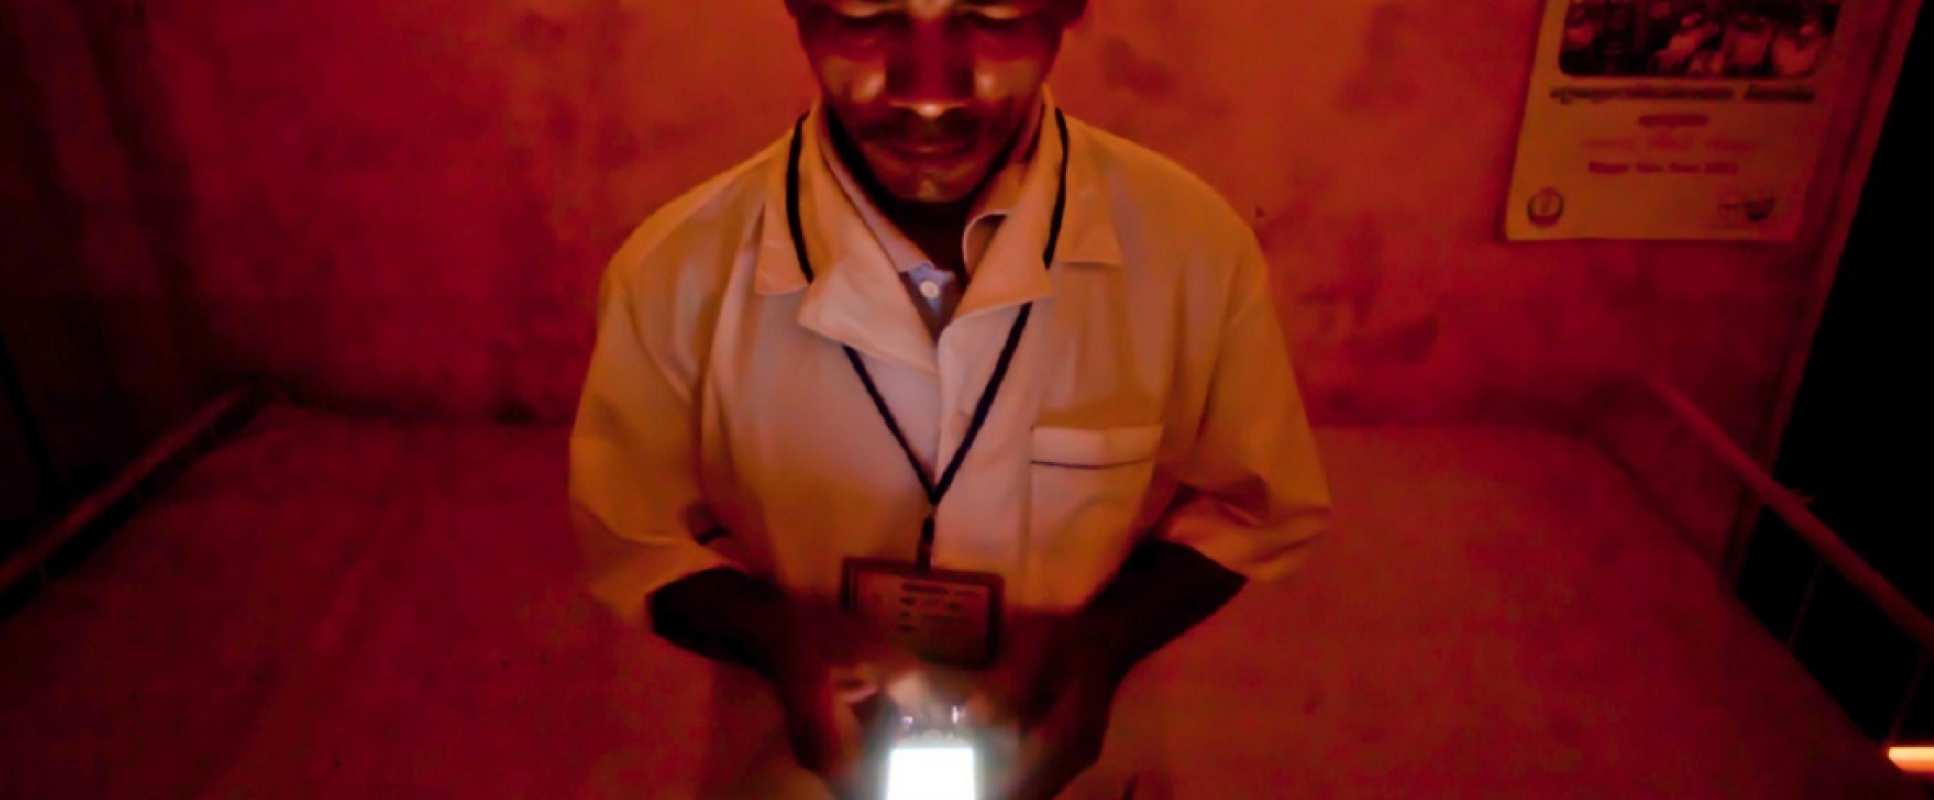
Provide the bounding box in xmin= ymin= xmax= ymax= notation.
xmin=0 ymin=408 xmax=1917 ymax=798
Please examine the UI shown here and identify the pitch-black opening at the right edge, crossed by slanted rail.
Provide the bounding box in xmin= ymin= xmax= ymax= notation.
xmin=1741 ymin=3 xmax=1934 ymax=742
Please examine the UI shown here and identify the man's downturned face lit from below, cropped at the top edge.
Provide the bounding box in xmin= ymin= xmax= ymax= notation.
xmin=789 ymin=0 xmax=1085 ymax=203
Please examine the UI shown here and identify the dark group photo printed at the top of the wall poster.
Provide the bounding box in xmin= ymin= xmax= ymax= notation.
xmin=1559 ymin=0 xmax=1841 ymax=79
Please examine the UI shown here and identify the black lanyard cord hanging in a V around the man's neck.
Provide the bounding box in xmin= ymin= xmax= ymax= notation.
xmin=785 ymin=108 xmax=1068 ymax=572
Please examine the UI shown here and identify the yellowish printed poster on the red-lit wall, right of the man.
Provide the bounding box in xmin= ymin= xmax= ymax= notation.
xmin=1505 ymin=0 xmax=1862 ymax=242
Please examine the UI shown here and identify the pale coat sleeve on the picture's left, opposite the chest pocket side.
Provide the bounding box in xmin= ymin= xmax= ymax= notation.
xmin=571 ymin=260 xmax=733 ymax=624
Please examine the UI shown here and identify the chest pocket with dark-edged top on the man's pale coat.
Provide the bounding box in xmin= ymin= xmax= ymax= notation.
xmin=1029 ymin=425 xmax=1162 ymax=558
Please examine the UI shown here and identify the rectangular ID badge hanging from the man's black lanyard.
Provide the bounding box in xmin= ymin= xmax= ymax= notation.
xmin=839 ymin=558 xmax=1002 ymax=667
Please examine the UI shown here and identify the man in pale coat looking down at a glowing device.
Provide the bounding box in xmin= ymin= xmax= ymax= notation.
xmin=571 ymin=0 xmax=1329 ymax=798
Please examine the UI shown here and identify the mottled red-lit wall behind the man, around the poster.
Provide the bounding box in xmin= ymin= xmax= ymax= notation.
xmin=0 ymin=0 xmax=1893 ymax=541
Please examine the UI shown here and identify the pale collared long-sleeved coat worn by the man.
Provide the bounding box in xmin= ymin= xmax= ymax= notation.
xmin=571 ymin=88 xmax=1329 ymax=618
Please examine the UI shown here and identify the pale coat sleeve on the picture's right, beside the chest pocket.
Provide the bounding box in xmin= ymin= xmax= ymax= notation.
xmin=1157 ymin=232 xmax=1331 ymax=580
